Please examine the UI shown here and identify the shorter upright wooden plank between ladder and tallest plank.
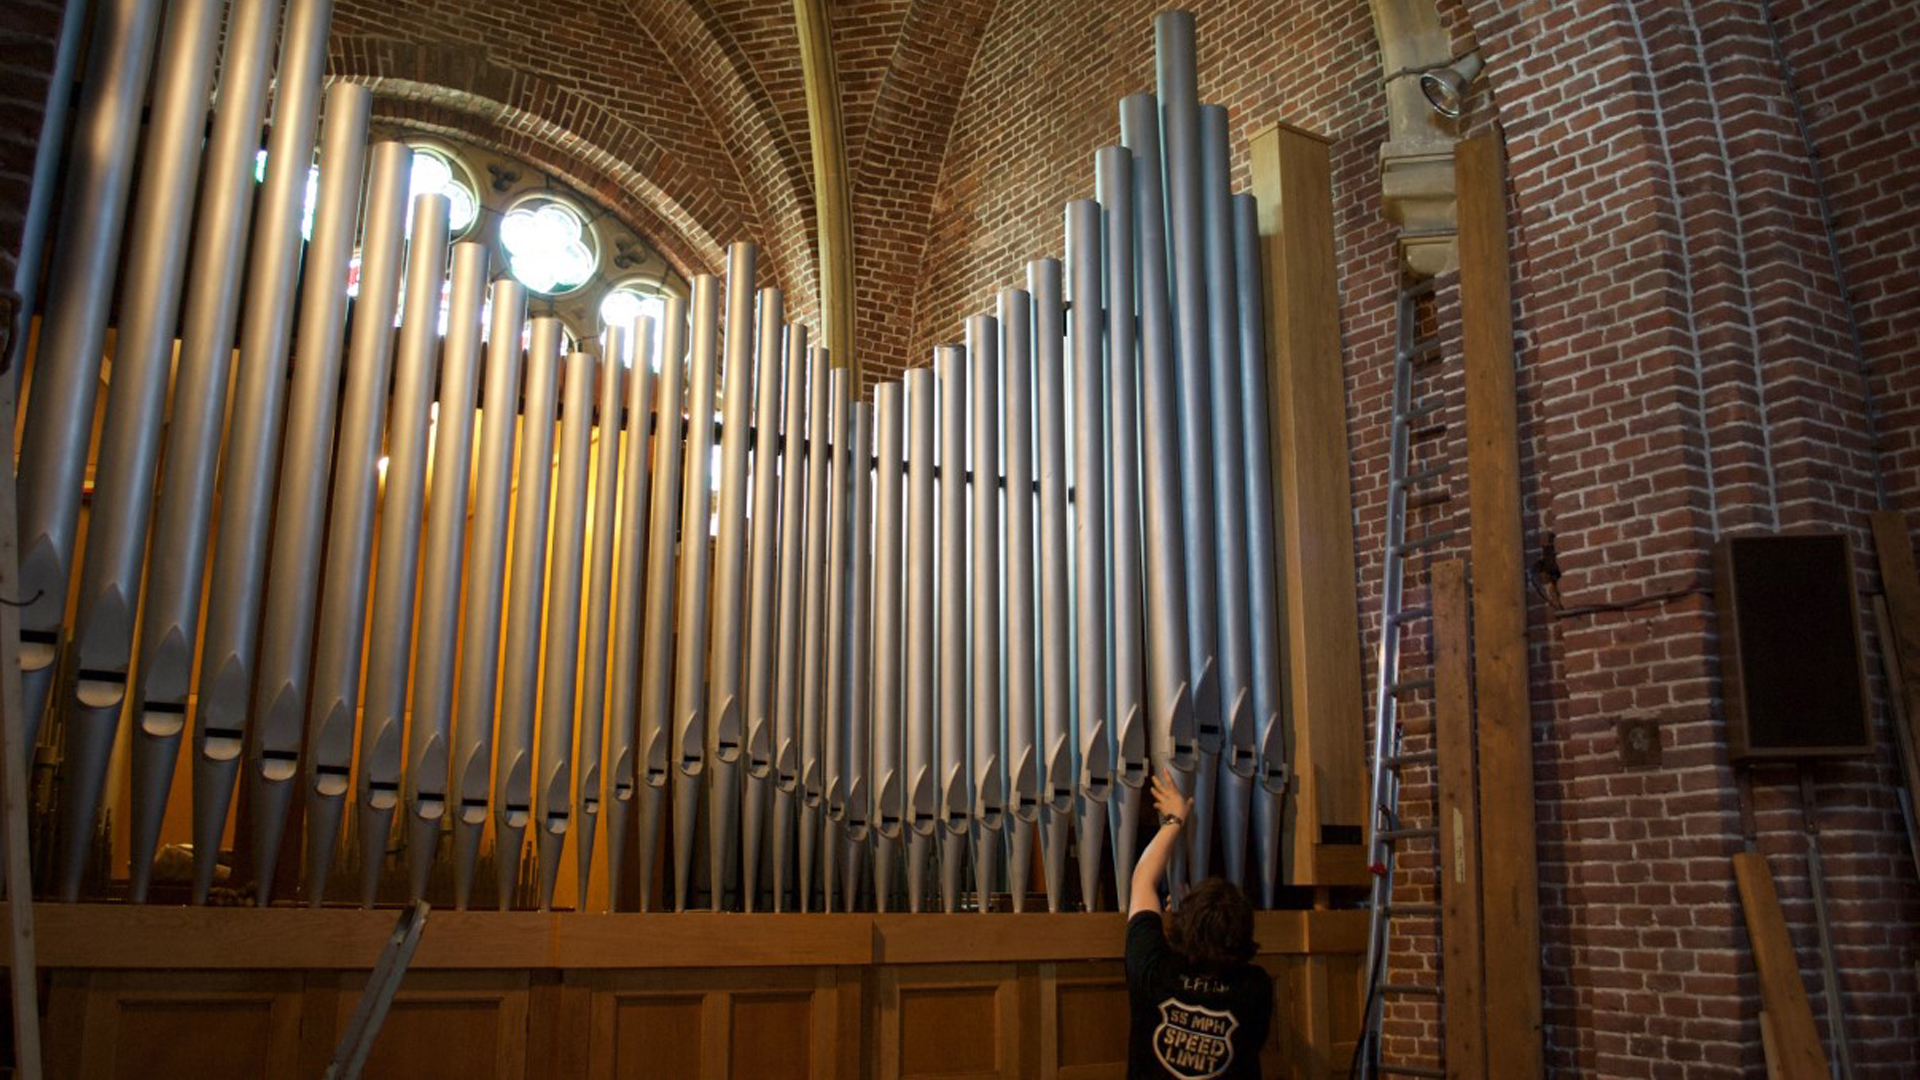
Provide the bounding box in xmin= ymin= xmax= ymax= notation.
xmin=1432 ymin=559 xmax=1486 ymax=1080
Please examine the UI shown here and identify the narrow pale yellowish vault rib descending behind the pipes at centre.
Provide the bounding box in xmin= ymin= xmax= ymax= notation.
xmin=793 ymin=0 xmax=860 ymax=382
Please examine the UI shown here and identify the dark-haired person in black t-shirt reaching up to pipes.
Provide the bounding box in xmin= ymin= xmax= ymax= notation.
xmin=1127 ymin=776 xmax=1273 ymax=1080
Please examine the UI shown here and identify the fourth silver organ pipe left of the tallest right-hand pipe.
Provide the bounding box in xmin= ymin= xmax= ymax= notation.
xmin=1027 ymin=259 xmax=1073 ymax=911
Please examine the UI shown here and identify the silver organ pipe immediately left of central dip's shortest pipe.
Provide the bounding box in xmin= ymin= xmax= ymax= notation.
xmin=821 ymin=367 xmax=854 ymax=911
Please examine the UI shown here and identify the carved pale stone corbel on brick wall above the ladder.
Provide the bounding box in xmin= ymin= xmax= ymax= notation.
xmin=1369 ymin=0 xmax=1459 ymax=277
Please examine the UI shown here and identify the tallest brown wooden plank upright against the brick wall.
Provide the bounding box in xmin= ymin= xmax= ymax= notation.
xmin=1453 ymin=135 xmax=1542 ymax=1076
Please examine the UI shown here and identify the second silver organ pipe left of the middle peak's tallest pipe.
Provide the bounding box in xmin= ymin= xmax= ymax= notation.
xmin=637 ymin=297 xmax=691 ymax=911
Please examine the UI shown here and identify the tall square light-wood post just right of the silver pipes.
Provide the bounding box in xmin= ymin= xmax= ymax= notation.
xmin=1250 ymin=125 xmax=1367 ymax=886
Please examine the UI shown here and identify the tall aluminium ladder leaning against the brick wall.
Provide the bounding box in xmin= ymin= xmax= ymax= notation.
xmin=1352 ymin=277 xmax=1455 ymax=1080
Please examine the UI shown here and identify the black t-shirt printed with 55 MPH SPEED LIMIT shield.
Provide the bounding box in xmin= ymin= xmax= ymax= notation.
xmin=1127 ymin=911 xmax=1273 ymax=1080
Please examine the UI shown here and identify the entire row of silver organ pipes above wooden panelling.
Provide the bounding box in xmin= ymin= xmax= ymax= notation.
xmin=17 ymin=0 xmax=1286 ymax=911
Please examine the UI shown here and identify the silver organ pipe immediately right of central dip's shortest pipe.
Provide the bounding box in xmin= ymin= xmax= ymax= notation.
xmin=868 ymin=382 xmax=906 ymax=911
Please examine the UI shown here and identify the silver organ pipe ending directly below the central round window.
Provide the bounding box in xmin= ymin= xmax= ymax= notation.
xmin=493 ymin=315 xmax=563 ymax=911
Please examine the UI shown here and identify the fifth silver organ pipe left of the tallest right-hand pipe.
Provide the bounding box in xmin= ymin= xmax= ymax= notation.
xmin=998 ymin=288 xmax=1041 ymax=911
